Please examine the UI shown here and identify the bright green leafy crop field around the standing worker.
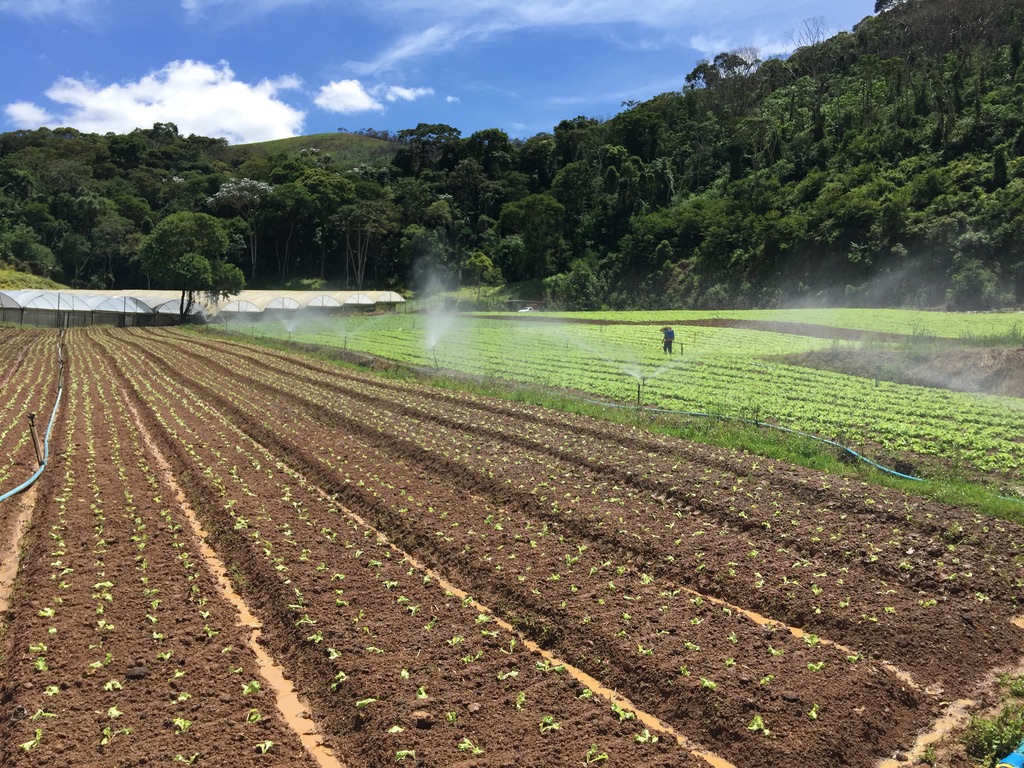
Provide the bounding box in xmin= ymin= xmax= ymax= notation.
xmin=211 ymin=309 xmax=1024 ymax=479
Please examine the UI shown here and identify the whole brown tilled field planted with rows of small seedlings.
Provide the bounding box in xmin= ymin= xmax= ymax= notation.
xmin=0 ymin=330 xmax=1024 ymax=767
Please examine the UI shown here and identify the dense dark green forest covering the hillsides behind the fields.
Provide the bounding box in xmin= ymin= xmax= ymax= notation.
xmin=0 ymin=0 xmax=1024 ymax=309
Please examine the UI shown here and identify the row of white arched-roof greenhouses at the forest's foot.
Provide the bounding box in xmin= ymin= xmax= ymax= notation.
xmin=0 ymin=290 xmax=404 ymax=326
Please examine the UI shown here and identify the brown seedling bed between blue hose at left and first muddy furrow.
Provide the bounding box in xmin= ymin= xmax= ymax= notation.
xmin=0 ymin=333 xmax=309 ymax=766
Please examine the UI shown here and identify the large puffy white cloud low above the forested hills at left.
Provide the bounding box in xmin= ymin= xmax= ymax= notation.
xmin=6 ymin=60 xmax=305 ymax=143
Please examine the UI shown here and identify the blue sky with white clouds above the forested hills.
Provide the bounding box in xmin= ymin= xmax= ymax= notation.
xmin=0 ymin=0 xmax=874 ymax=143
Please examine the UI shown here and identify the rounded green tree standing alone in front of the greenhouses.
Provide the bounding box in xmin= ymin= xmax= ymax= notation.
xmin=138 ymin=211 xmax=245 ymax=322
